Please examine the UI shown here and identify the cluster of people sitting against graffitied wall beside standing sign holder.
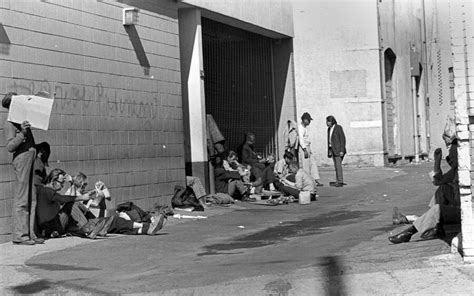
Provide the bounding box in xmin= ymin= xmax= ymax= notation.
xmin=34 ymin=142 xmax=166 ymax=239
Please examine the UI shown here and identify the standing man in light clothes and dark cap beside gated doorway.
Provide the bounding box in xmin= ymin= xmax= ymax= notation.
xmin=298 ymin=112 xmax=323 ymax=186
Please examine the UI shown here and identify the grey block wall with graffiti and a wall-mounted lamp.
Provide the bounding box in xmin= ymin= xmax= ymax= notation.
xmin=0 ymin=0 xmax=185 ymax=240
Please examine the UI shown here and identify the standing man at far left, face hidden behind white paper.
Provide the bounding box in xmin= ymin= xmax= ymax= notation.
xmin=2 ymin=93 xmax=49 ymax=245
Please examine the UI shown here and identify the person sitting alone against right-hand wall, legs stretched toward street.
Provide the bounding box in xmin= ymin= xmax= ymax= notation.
xmin=388 ymin=135 xmax=461 ymax=244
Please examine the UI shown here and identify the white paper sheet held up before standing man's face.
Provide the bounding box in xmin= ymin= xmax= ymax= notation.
xmin=7 ymin=95 xmax=54 ymax=130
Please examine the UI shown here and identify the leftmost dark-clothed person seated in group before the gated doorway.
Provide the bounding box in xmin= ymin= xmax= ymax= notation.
xmin=214 ymin=156 xmax=250 ymax=201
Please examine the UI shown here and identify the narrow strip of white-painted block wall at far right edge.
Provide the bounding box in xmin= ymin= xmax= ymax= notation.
xmin=449 ymin=1 xmax=474 ymax=262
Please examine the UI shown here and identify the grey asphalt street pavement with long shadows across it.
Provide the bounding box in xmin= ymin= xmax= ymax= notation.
xmin=2 ymin=163 xmax=473 ymax=295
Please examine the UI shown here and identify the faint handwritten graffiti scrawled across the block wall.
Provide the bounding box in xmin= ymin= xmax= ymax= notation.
xmin=7 ymin=80 xmax=161 ymax=125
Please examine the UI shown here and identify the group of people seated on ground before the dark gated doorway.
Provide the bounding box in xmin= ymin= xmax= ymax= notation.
xmin=214 ymin=133 xmax=317 ymax=201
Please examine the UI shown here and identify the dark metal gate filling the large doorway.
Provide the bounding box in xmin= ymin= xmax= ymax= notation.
xmin=201 ymin=18 xmax=276 ymax=154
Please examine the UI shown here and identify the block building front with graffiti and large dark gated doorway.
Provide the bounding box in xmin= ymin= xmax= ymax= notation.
xmin=0 ymin=0 xmax=295 ymax=241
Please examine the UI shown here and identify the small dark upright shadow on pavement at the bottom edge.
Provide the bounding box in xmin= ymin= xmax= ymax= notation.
xmin=318 ymin=256 xmax=347 ymax=296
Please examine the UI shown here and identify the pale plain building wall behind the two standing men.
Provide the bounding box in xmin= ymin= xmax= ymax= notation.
xmin=293 ymin=0 xmax=383 ymax=166
